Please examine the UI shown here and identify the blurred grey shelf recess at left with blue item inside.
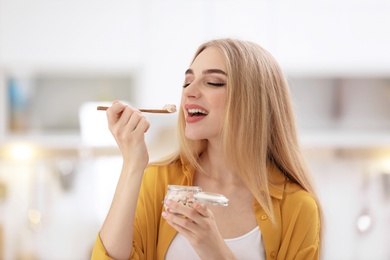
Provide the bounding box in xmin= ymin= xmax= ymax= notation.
xmin=0 ymin=71 xmax=136 ymax=135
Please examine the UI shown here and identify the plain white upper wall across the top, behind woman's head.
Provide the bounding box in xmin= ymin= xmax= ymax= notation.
xmin=0 ymin=0 xmax=390 ymax=105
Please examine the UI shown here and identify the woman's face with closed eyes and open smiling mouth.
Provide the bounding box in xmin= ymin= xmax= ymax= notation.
xmin=181 ymin=47 xmax=227 ymax=140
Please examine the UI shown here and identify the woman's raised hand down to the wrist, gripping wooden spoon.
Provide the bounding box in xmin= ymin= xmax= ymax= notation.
xmin=107 ymin=101 xmax=150 ymax=171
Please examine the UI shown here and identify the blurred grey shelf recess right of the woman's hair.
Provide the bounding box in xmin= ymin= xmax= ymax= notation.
xmin=289 ymin=76 xmax=390 ymax=148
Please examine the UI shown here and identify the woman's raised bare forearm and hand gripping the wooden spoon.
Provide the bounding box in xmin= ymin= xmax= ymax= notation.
xmin=94 ymin=101 xmax=150 ymax=259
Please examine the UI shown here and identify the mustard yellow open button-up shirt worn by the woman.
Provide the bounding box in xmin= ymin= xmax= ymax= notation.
xmin=91 ymin=157 xmax=320 ymax=260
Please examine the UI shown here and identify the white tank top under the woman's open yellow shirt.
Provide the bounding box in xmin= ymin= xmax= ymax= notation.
xmin=165 ymin=226 xmax=265 ymax=260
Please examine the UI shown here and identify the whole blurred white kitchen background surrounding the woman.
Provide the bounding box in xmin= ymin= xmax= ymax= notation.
xmin=0 ymin=0 xmax=390 ymax=260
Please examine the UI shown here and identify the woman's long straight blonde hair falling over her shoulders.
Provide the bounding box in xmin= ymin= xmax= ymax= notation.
xmin=154 ymin=39 xmax=320 ymax=231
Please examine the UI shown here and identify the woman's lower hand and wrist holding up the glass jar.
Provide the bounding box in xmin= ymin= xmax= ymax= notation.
xmin=162 ymin=200 xmax=236 ymax=259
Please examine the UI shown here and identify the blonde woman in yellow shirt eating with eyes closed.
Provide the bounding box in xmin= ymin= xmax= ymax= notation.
xmin=92 ymin=39 xmax=321 ymax=260
